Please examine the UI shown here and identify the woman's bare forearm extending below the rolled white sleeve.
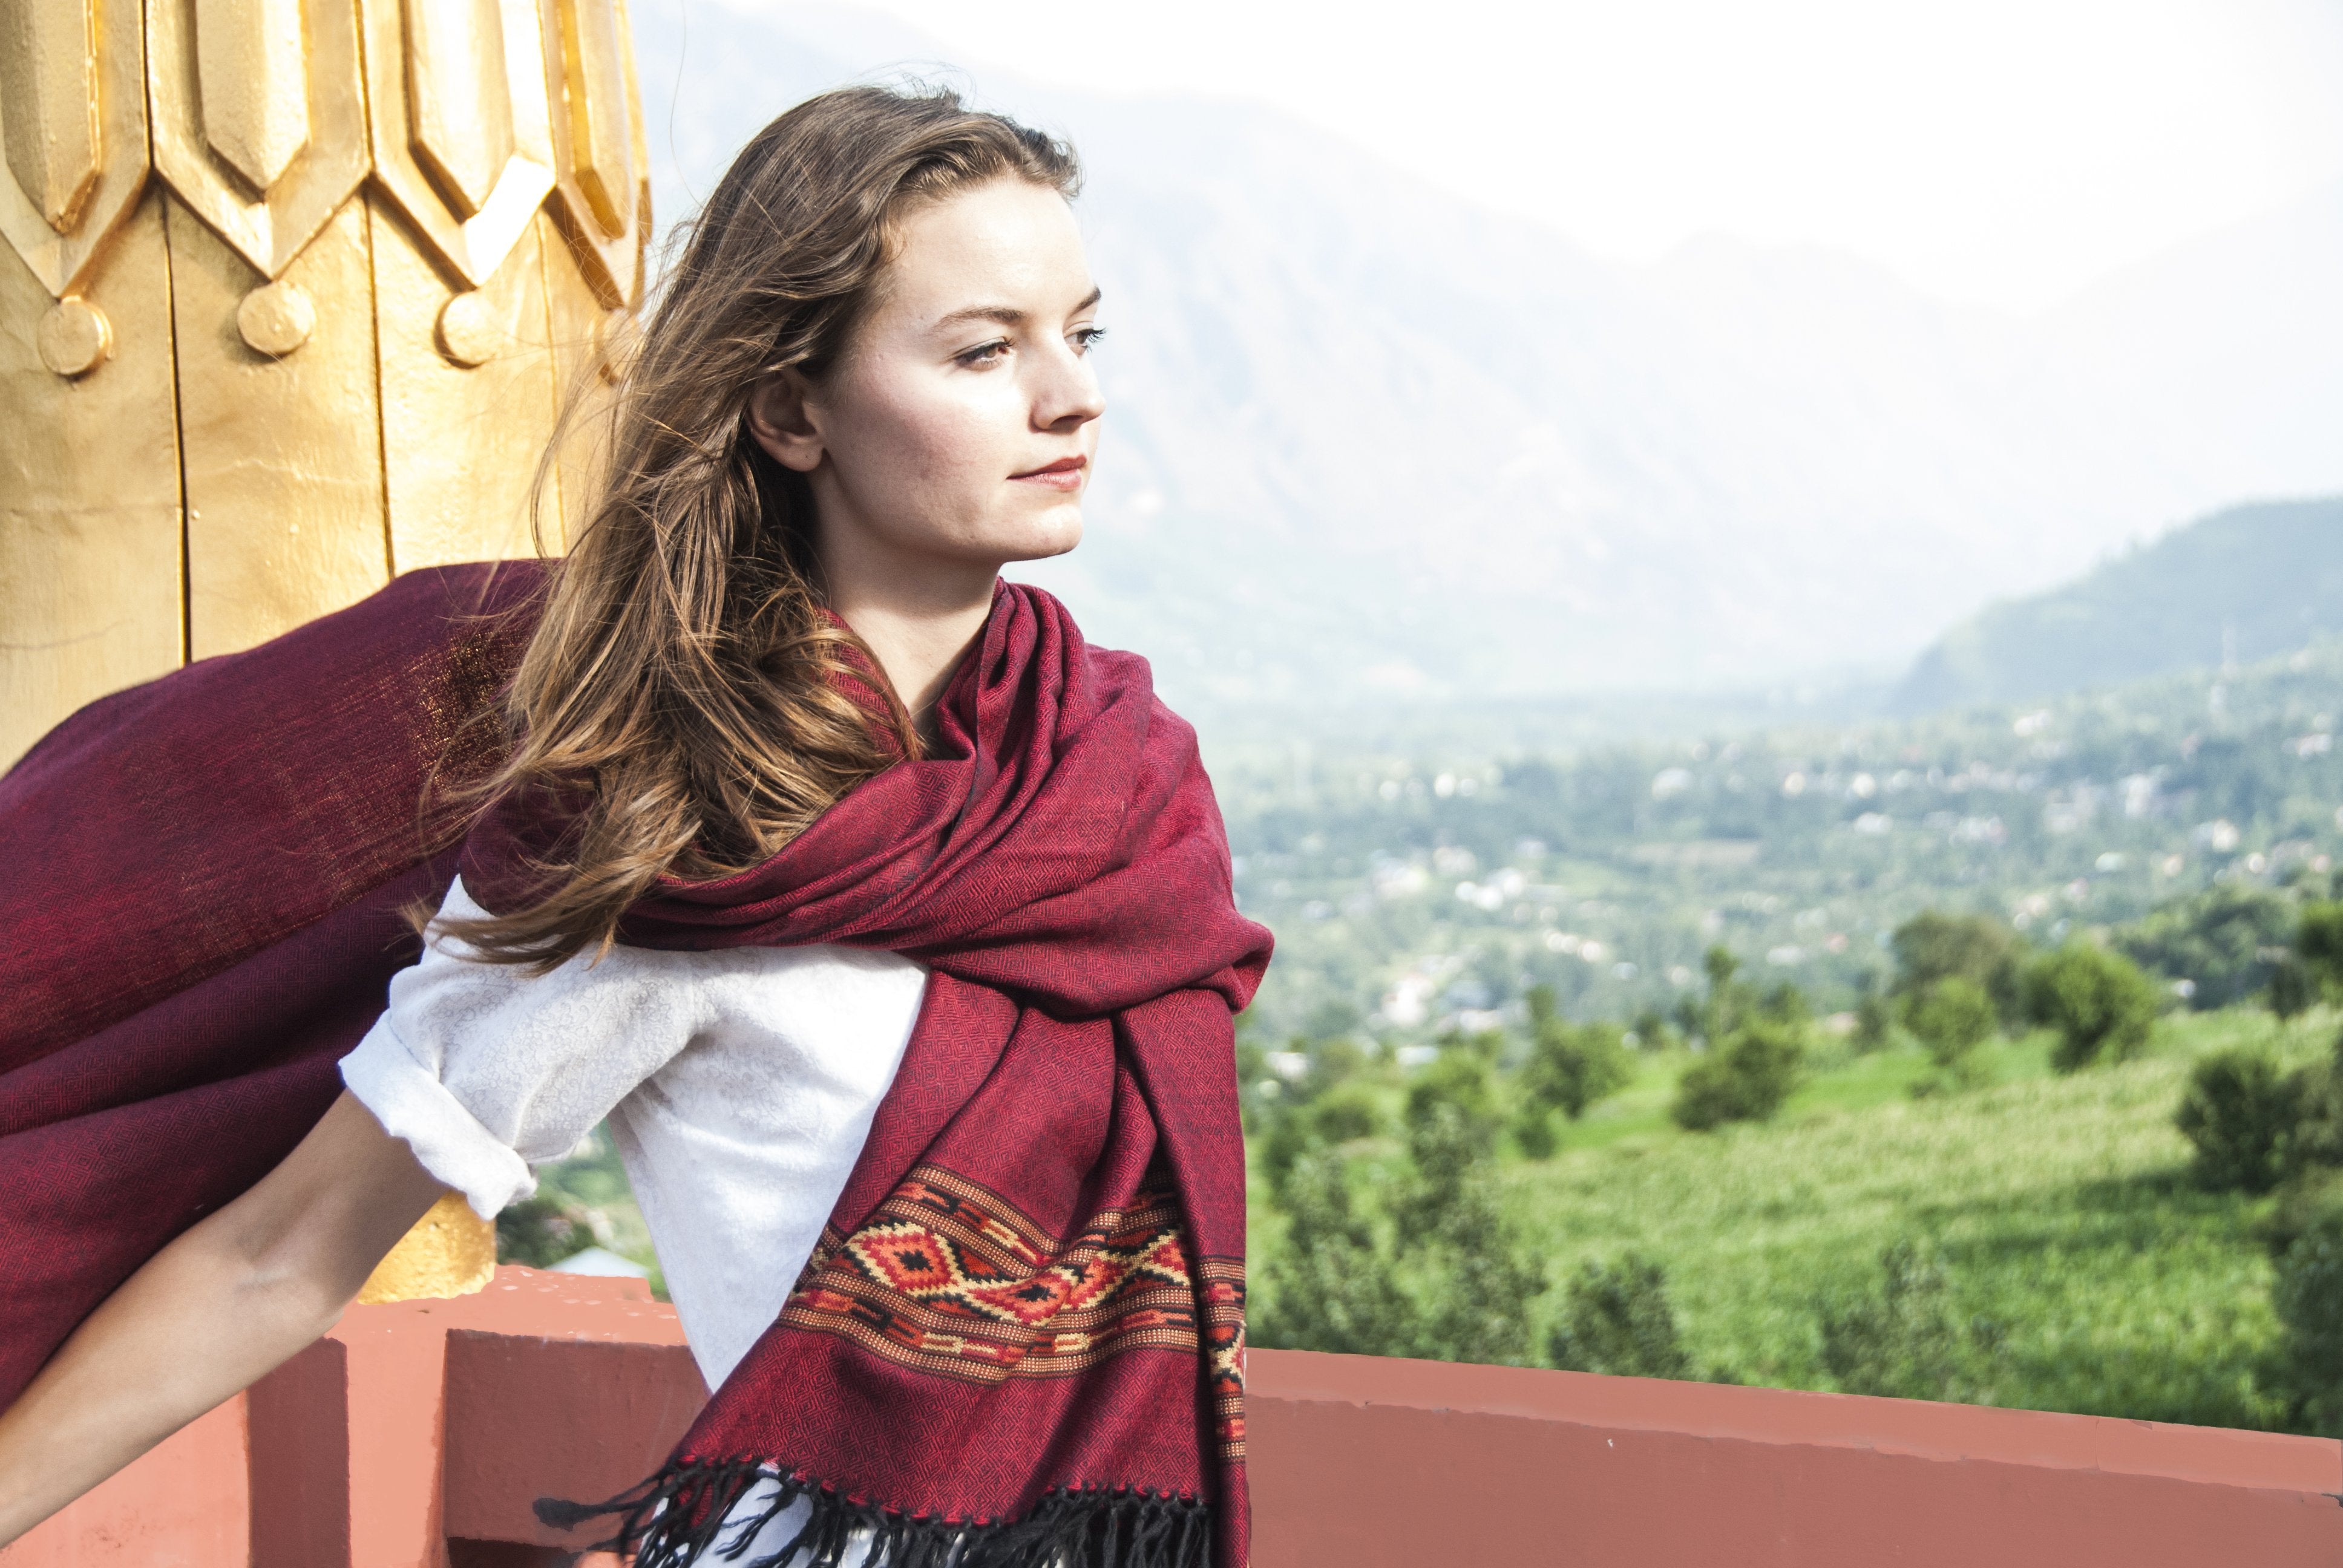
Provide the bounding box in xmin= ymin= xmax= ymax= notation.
xmin=0 ymin=1094 xmax=445 ymax=1544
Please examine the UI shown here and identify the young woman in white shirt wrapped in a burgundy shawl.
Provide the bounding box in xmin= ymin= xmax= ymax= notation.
xmin=0 ymin=89 xmax=1268 ymax=1568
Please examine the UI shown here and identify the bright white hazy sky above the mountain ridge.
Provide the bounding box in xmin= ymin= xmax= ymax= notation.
xmin=745 ymin=0 xmax=2343 ymax=307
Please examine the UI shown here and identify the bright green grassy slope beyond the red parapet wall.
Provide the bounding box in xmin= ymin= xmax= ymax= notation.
xmin=1251 ymin=1010 xmax=2332 ymax=1428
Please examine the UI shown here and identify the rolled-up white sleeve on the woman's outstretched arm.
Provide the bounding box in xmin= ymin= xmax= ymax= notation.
xmin=342 ymin=881 xmax=707 ymax=1219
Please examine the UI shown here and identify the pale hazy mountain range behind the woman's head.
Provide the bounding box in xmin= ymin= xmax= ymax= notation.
xmin=628 ymin=0 xmax=2343 ymax=708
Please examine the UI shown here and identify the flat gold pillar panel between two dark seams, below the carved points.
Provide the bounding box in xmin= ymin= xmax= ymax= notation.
xmin=166 ymin=199 xmax=392 ymax=659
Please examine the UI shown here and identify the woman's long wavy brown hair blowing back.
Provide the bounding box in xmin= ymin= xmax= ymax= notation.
xmin=441 ymin=87 xmax=1080 ymax=968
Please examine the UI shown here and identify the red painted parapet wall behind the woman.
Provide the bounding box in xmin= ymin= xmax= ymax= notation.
xmin=0 ymin=1268 xmax=2343 ymax=1568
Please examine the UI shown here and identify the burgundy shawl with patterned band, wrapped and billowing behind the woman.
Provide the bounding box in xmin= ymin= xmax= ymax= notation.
xmin=0 ymin=567 xmax=1270 ymax=1568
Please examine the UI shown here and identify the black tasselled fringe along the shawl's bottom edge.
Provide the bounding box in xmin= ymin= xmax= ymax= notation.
xmin=537 ymin=1460 xmax=1211 ymax=1568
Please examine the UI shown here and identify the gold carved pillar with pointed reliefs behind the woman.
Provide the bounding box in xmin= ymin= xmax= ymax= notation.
xmin=0 ymin=0 xmax=651 ymax=1298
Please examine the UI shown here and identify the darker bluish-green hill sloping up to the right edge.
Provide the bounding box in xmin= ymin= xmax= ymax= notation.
xmin=1891 ymin=497 xmax=2343 ymax=713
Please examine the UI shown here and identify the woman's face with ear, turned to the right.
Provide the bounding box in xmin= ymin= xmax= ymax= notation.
xmin=750 ymin=178 xmax=1106 ymax=577
